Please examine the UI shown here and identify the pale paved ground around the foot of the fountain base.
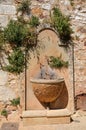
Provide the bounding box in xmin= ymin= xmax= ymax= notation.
xmin=0 ymin=111 xmax=86 ymax=130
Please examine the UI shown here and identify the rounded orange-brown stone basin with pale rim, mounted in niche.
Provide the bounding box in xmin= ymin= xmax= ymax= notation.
xmin=30 ymin=78 xmax=64 ymax=103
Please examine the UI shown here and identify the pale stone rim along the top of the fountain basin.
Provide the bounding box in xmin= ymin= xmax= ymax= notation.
xmin=30 ymin=78 xmax=64 ymax=84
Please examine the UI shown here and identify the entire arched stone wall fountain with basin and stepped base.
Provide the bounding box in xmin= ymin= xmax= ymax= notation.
xmin=22 ymin=29 xmax=74 ymax=125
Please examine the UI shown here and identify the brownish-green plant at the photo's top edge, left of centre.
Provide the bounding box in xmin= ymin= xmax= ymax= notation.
xmin=17 ymin=0 xmax=31 ymax=15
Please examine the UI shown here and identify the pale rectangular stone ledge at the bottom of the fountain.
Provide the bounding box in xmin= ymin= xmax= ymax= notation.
xmin=22 ymin=109 xmax=71 ymax=126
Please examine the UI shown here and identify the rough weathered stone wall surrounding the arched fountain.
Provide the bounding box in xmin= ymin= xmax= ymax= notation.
xmin=0 ymin=0 xmax=86 ymax=109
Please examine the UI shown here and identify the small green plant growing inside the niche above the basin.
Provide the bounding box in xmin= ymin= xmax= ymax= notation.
xmin=49 ymin=56 xmax=68 ymax=68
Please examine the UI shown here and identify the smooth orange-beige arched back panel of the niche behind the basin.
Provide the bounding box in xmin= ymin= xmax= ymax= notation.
xmin=27 ymin=29 xmax=73 ymax=110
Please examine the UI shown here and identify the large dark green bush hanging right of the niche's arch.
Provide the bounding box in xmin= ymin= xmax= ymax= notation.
xmin=52 ymin=8 xmax=72 ymax=45
